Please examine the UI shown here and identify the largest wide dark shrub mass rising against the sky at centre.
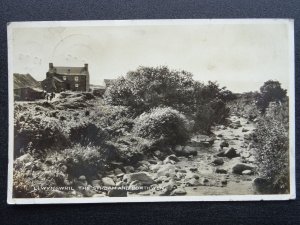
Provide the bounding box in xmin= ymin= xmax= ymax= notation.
xmin=104 ymin=66 xmax=230 ymax=133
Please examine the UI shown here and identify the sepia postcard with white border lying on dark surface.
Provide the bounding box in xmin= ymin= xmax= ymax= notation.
xmin=7 ymin=19 xmax=296 ymax=204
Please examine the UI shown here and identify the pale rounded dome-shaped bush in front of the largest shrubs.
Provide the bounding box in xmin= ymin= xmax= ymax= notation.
xmin=133 ymin=107 xmax=189 ymax=145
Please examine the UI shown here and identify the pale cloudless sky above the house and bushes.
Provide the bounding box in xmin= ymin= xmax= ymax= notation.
xmin=9 ymin=20 xmax=293 ymax=93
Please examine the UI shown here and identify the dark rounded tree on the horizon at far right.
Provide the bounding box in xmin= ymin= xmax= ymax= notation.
xmin=257 ymin=80 xmax=287 ymax=113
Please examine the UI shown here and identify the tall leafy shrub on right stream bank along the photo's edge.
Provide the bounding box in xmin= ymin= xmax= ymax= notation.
xmin=255 ymin=103 xmax=289 ymax=193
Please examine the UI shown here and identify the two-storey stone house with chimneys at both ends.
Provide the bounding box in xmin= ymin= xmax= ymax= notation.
xmin=41 ymin=63 xmax=90 ymax=92
